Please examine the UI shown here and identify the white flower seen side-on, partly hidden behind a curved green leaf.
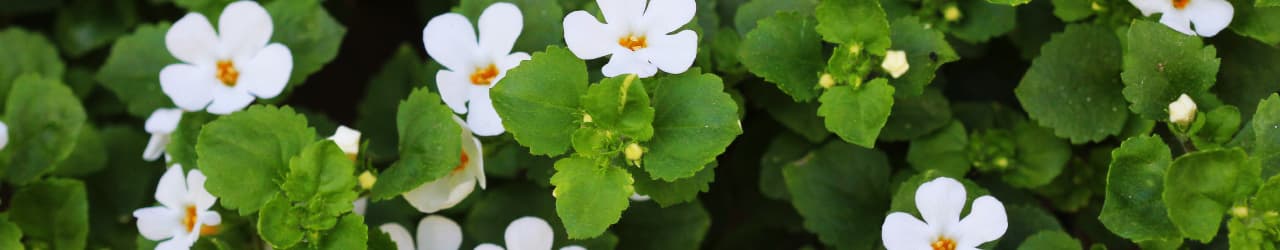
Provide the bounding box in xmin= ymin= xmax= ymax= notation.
xmin=403 ymin=117 xmax=485 ymax=213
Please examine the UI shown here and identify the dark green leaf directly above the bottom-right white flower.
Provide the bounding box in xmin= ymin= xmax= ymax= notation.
xmin=906 ymin=122 xmax=972 ymax=176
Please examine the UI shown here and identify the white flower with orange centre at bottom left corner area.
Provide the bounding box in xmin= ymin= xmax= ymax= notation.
xmin=133 ymin=164 xmax=223 ymax=249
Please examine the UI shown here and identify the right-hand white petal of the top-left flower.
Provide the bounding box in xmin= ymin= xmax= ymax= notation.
xmin=236 ymin=44 xmax=293 ymax=99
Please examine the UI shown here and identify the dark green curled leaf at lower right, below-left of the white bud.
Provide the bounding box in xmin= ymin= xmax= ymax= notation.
xmin=1098 ymin=136 xmax=1181 ymax=241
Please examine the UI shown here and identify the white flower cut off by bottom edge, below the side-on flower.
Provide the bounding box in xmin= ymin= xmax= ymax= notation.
xmin=378 ymin=215 xmax=462 ymax=250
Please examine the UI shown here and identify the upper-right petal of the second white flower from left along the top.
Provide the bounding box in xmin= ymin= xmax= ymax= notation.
xmin=479 ymin=3 xmax=525 ymax=56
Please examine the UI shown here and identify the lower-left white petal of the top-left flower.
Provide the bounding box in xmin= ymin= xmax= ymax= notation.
xmin=160 ymin=64 xmax=221 ymax=112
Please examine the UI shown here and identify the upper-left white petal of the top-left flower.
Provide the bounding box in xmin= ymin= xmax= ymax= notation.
xmin=164 ymin=13 xmax=218 ymax=65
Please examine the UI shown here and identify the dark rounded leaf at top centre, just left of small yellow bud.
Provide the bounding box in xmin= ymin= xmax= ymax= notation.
xmin=739 ymin=12 xmax=826 ymax=103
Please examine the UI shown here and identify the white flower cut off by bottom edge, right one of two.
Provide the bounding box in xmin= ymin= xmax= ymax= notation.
xmin=476 ymin=217 xmax=586 ymax=250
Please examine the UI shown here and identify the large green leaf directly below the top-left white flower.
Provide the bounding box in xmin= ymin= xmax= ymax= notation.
xmin=196 ymin=105 xmax=316 ymax=214
